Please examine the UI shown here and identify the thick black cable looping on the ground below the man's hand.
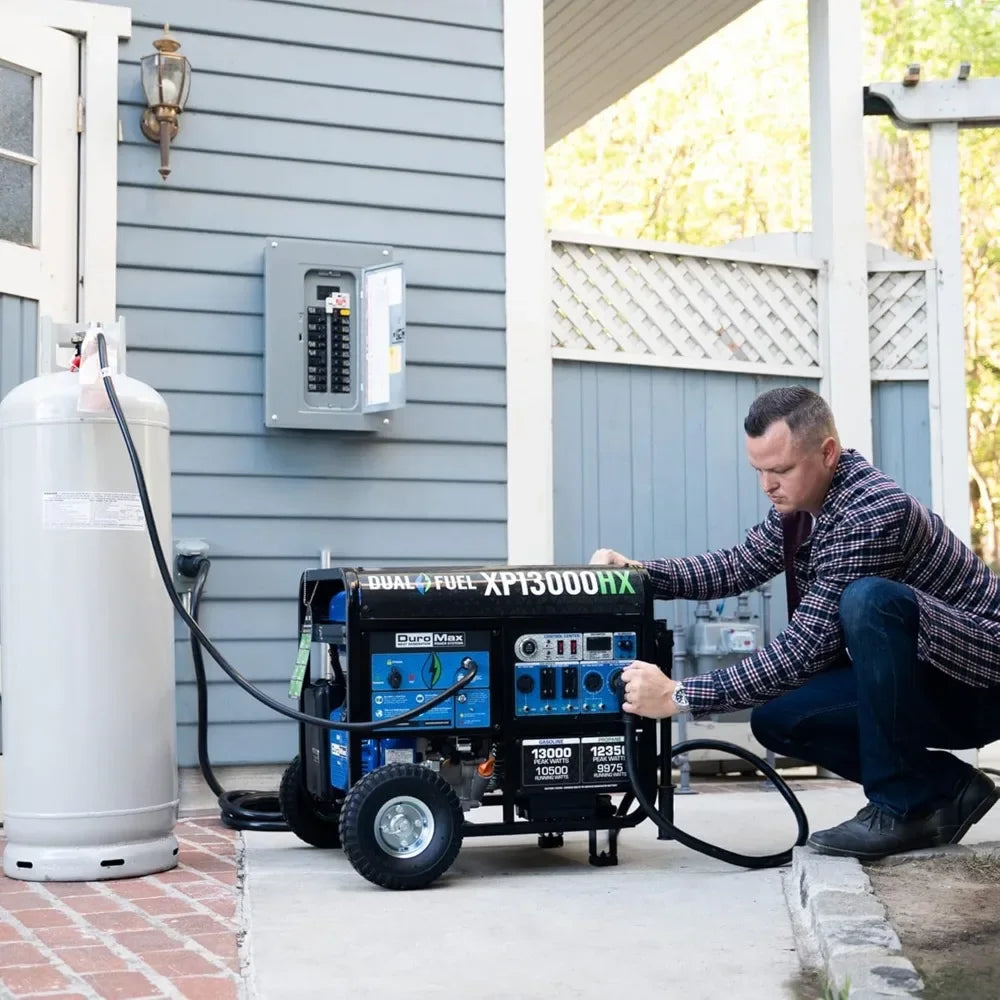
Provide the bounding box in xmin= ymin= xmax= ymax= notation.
xmin=624 ymin=712 xmax=809 ymax=868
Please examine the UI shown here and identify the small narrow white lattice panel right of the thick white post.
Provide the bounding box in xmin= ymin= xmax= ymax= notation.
xmin=868 ymin=271 xmax=934 ymax=373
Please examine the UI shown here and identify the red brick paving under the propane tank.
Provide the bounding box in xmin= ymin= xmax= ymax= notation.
xmin=0 ymin=817 xmax=243 ymax=1000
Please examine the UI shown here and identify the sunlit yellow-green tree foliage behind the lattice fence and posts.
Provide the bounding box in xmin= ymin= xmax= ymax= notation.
xmin=546 ymin=0 xmax=1000 ymax=565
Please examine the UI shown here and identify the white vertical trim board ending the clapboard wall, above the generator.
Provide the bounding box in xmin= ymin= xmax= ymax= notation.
xmin=503 ymin=0 xmax=554 ymax=565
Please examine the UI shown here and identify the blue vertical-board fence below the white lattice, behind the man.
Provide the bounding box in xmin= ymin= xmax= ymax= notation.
xmin=553 ymin=361 xmax=930 ymax=642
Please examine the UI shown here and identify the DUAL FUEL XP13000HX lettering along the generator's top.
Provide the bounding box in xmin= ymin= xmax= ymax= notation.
xmin=362 ymin=569 xmax=635 ymax=597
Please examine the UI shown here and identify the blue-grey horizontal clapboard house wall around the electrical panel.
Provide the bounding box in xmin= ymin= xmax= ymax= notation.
xmin=92 ymin=0 xmax=507 ymax=765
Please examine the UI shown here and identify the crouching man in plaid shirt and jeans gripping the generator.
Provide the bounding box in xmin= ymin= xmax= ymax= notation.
xmin=591 ymin=386 xmax=1000 ymax=859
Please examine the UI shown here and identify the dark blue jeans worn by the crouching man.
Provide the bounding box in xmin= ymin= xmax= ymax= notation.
xmin=750 ymin=577 xmax=1000 ymax=819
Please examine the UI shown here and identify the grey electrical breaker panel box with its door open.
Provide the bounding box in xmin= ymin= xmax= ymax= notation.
xmin=264 ymin=239 xmax=406 ymax=432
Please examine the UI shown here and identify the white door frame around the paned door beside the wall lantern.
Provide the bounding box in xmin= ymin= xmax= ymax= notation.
xmin=0 ymin=0 xmax=132 ymax=323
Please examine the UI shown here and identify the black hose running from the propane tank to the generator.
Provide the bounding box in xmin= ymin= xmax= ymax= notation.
xmin=97 ymin=333 xmax=479 ymax=733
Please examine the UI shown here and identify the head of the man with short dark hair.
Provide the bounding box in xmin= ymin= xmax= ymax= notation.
xmin=743 ymin=385 xmax=840 ymax=514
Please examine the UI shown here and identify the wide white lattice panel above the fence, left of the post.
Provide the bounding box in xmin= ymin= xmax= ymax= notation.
xmin=552 ymin=241 xmax=819 ymax=369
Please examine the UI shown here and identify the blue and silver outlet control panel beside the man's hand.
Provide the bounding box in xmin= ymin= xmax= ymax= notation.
xmin=514 ymin=632 xmax=636 ymax=717
